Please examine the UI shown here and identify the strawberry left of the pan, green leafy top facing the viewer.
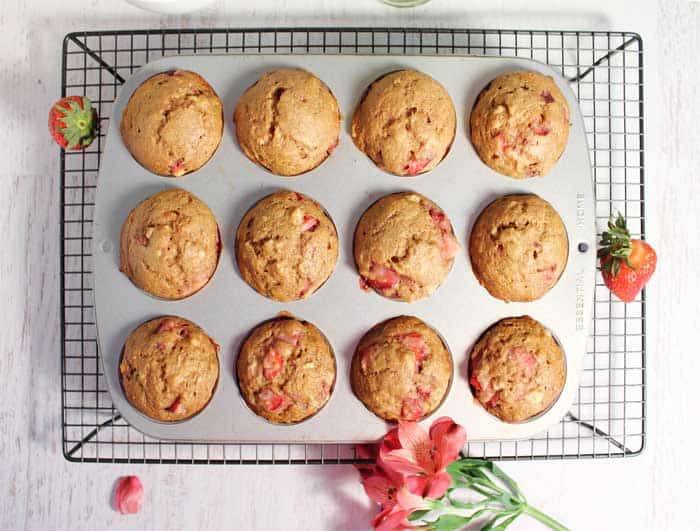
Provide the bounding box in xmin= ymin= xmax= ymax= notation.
xmin=49 ymin=96 xmax=98 ymax=149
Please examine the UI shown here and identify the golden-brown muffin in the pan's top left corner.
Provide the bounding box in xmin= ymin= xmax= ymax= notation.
xmin=119 ymin=70 xmax=224 ymax=177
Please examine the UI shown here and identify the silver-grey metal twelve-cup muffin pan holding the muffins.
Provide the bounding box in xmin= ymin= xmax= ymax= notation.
xmin=93 ymin=55 xmax=595 ymax=443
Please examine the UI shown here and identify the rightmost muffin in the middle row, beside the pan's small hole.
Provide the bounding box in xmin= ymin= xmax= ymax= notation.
xmin=469 ymin=195 xmax=569 ymax=302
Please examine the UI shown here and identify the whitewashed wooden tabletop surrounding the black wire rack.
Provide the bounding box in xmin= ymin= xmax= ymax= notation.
xmin=0 ymin=0 xmax=700 ymax=530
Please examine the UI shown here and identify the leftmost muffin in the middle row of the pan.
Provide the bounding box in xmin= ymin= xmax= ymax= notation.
xmin=119 ymin=188 xmax=221 ymax=299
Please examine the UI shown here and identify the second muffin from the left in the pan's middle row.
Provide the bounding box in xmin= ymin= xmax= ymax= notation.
xmin=236 ymin=190 xmax=338 ymax=302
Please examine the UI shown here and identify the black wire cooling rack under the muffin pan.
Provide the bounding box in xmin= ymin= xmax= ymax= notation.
xmin=61 ymin=28 xmax=646 ymax=464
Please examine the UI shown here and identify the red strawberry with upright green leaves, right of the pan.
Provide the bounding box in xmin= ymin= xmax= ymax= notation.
xmin=598 ymin=213 xmax=656 ymax=302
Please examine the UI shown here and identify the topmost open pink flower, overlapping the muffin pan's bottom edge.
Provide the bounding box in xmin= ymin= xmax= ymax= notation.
xmin=377 ymin=417 xmax=467 ymax=499
